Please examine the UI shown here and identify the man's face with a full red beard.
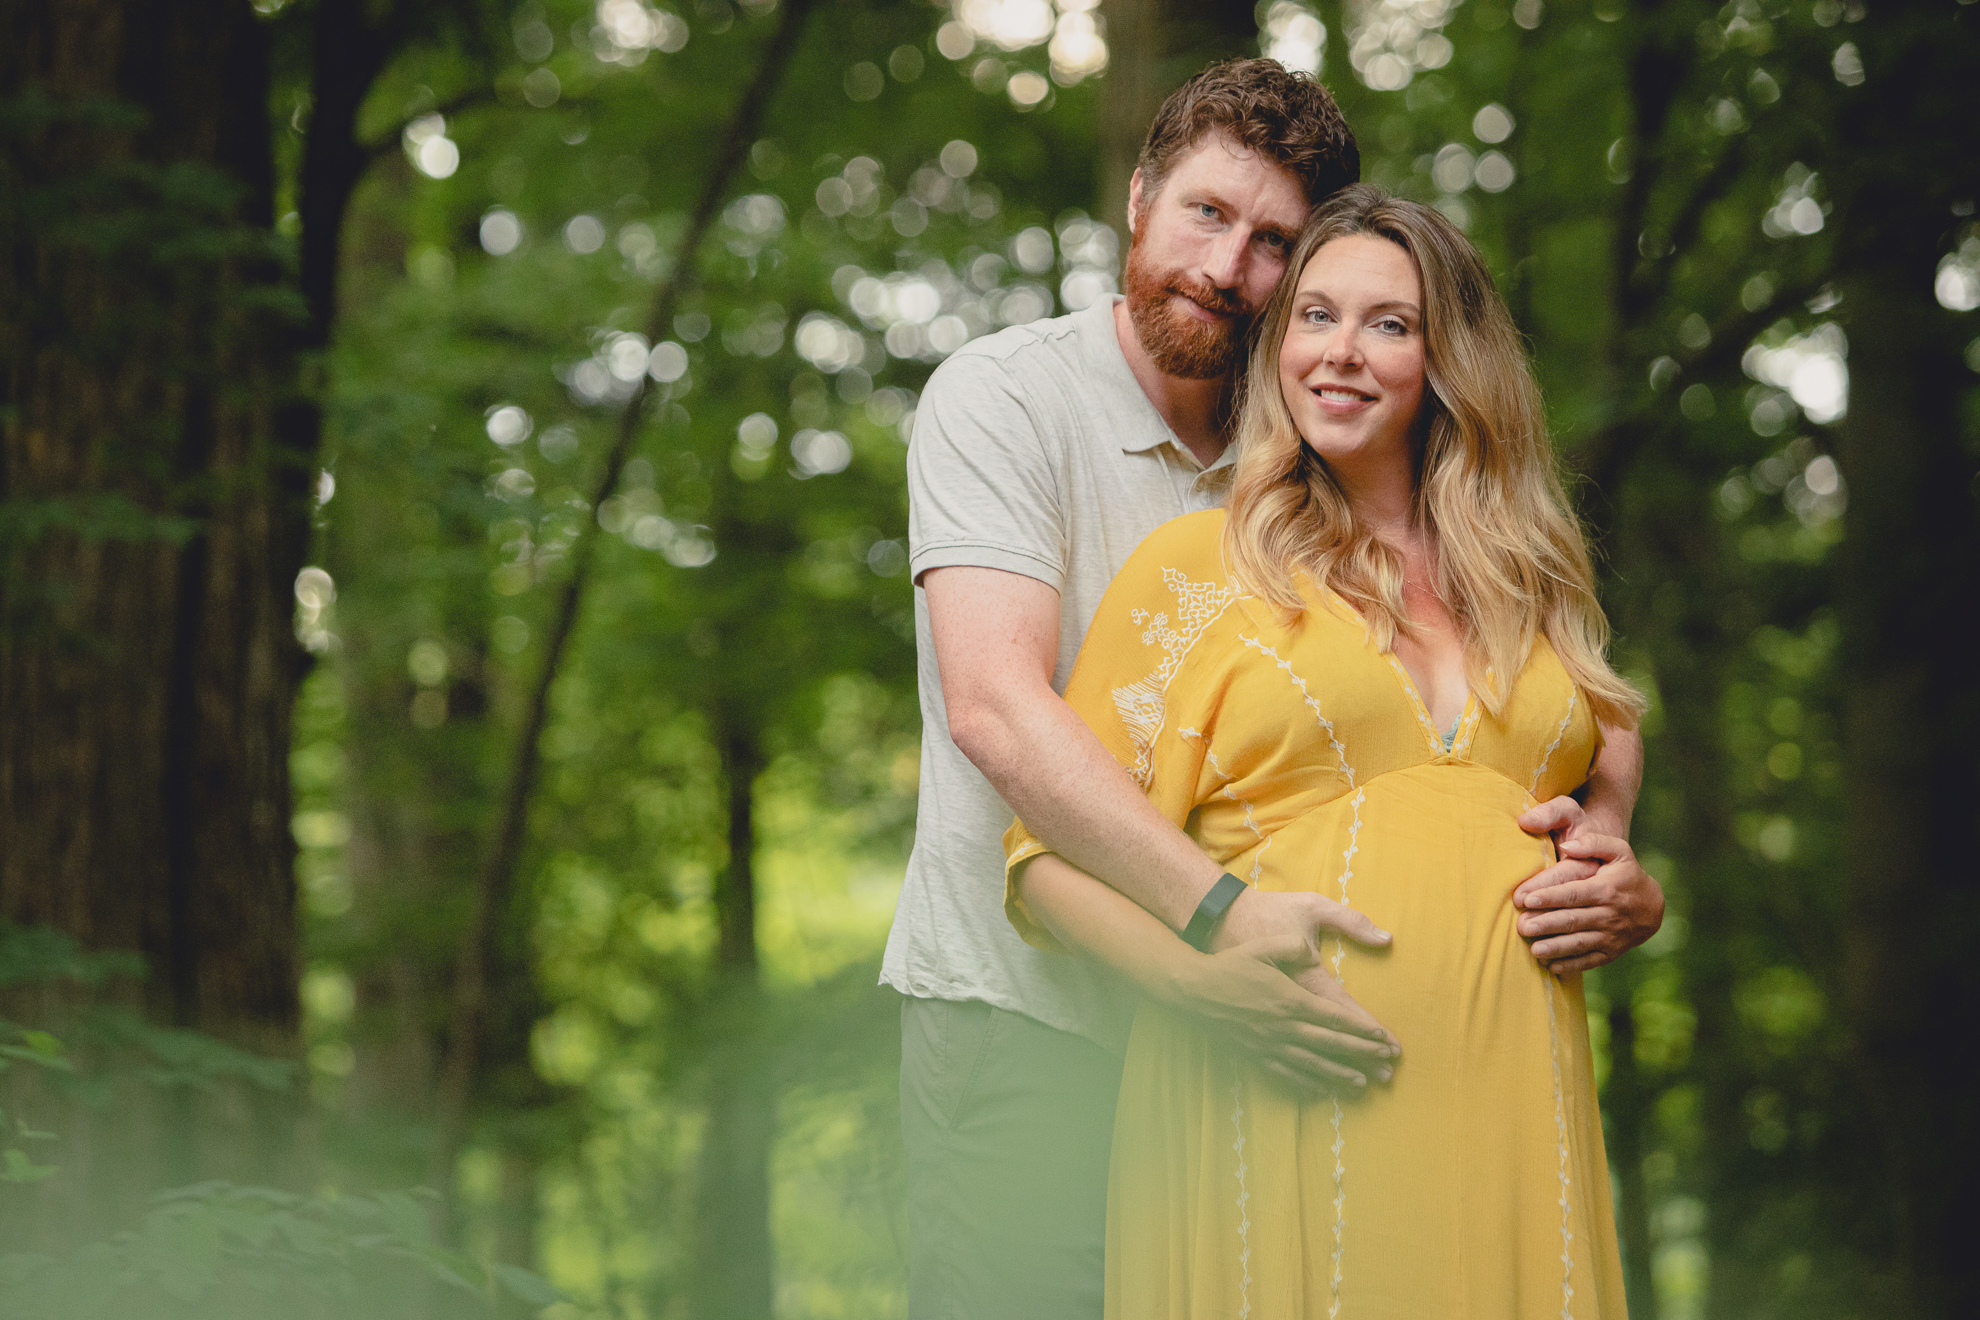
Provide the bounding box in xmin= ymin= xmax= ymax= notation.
xmin=1127 ymin=133 xmax=1307 ymax=380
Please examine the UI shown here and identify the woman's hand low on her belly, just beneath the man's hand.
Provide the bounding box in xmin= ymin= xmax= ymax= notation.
xmin=1166 ymin=930 xmax=1402 ymax=1102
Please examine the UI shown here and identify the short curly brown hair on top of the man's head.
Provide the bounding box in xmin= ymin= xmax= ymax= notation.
xmin=1135 ymin=59 xmax=1360 ymax=202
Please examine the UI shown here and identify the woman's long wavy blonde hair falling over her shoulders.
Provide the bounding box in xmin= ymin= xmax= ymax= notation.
xmin=1224 ymin=184 xmax=1643 ymax=726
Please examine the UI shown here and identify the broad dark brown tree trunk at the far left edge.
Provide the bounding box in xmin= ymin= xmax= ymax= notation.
xmin=0 ymin=0 xmax=309 ymax=1053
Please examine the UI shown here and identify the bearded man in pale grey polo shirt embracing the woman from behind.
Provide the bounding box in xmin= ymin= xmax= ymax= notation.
xmin=881 ymin=59 xmax=1661 ymax=1320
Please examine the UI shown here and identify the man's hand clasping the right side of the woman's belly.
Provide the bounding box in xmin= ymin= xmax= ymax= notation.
xmin=1513 ymin=798 xmax=1663 ymax=976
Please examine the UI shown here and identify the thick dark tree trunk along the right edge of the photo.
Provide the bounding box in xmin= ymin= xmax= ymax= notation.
xmin=1837 ymin=15 xmax=1980 ymax=1318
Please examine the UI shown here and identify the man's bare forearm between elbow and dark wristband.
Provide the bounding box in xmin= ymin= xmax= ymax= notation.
xmin=952 ymin=689 xmax=1222 ymax=930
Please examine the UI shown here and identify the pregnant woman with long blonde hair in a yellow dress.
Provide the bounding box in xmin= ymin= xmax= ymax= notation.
xmin=1006 ymin=186 xmax=1641 ymax=1320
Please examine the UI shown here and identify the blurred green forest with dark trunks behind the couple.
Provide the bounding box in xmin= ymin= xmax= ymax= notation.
xmin=0 ymin=0 xmax=1980 ymax=1320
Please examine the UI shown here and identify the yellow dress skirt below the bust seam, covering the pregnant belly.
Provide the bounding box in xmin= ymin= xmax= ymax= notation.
xmin=1109 ymin=764 xmax=1622 ymax=1320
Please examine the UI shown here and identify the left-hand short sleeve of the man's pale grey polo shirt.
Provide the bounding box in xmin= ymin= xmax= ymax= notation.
xmin=907 ymin=352 xmax=1065 ymax=592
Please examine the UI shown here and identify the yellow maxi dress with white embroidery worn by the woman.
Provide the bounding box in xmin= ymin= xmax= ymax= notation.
xmin=1006 ymin=511 xmax=1626 ymax=1320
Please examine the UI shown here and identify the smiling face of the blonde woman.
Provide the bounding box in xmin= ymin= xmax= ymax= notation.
xmin=1279 ymin=234 xmax=1424 ymax=471
